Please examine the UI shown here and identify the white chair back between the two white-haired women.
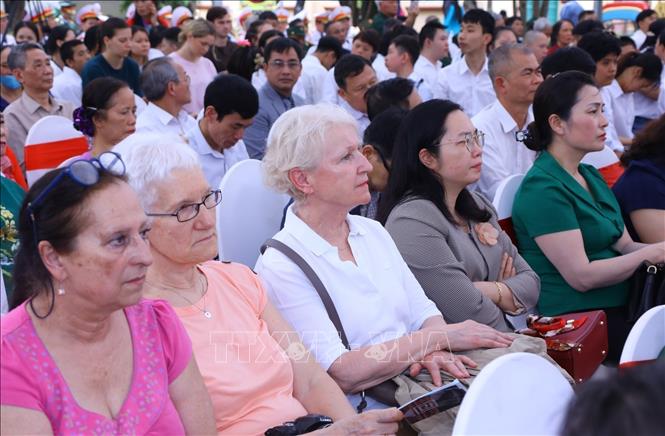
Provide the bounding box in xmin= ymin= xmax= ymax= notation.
xmin=217 ymin=159 xmax=289 ymax=268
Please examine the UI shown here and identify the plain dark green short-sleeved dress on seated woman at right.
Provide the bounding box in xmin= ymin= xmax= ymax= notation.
xmin=512 ymin=152 xmax=629 ymax=315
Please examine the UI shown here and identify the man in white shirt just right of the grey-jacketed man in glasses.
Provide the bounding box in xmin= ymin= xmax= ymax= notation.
xmin=293 ymin=36 xmax=343 ymax=104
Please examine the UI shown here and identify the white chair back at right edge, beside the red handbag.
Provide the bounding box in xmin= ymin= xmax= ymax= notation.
xmin=619 ymin=305 xmax=665 ymax=367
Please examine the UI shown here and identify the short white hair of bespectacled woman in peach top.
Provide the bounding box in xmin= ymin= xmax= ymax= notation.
xmin=113 ymin=133 xmax=201 ymax=210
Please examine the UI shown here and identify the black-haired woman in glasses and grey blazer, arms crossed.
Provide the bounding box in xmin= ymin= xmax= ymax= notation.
xmin=379 ymin=100 xmax=540 ymax=332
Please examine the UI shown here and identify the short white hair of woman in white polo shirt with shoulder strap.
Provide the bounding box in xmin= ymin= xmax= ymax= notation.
xmin=263 ymin=103 xmax=358 ymax=200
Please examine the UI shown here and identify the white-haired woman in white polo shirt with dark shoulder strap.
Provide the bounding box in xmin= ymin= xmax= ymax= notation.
xmin=255 ymin=104 xmax=512 ymax=408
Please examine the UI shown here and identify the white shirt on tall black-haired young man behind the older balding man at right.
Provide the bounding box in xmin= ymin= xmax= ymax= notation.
xmin=432 ymin=58 xmax=496 ymax=117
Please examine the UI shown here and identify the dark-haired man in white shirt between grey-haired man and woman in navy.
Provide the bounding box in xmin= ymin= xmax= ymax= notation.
xmin=51 ymin=39 xmax=90 ymax=107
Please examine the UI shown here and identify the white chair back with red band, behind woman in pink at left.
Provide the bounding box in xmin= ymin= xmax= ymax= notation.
xmin=25 ymin=115 xmax=88 ymax=185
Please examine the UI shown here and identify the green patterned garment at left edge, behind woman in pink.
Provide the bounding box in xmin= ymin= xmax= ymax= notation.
xmin=0 ymin=177 xmax=25 ymax=301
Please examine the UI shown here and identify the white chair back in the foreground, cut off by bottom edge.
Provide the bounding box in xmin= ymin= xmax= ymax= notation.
xmin=453 ymin=353 xmax=573 ymax=436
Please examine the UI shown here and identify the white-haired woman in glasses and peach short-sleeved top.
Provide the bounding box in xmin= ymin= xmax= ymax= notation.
xmin=116 ymin=133 xmax=402 ymax=434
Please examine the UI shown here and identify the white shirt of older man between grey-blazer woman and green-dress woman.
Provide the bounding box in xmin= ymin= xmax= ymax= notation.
xmin=471 ymin=100 xmax=536 ymax=200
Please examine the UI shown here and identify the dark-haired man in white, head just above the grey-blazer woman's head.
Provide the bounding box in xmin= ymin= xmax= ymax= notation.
xmin=386 ymin=35 xmax=432 ymax=101
